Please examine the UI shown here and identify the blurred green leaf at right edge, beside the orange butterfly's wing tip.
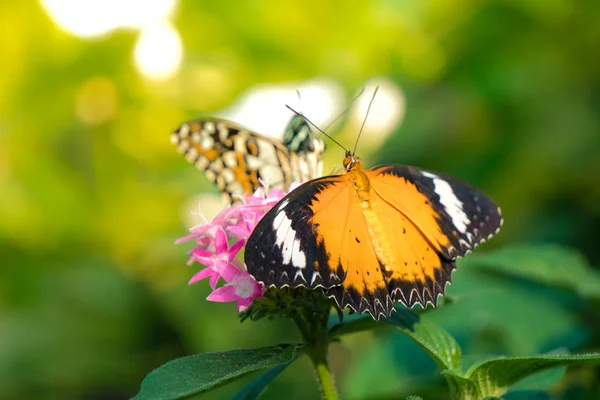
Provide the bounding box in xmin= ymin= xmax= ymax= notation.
xmin=462 ymin=244 xmax=600 ymax=298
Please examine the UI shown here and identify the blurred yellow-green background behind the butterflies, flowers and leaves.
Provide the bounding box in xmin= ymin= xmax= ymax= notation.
xmin=0 ymin=0 xmax=600 ymax=400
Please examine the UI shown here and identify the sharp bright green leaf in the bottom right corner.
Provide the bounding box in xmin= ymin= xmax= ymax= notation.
xmin=442 ymin=353 xmax=600 ymax=400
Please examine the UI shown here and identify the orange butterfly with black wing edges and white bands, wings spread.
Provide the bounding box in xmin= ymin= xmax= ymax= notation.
xmin=244 ymin=151 xmax=502 ymax=318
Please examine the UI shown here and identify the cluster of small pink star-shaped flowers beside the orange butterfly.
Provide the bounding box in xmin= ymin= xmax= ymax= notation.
xmin=176 ymin=188 xmax=291 ymax=312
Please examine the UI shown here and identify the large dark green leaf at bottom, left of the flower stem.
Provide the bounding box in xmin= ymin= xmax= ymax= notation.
xmin=135 ymin=345 xmax=301 ymax=400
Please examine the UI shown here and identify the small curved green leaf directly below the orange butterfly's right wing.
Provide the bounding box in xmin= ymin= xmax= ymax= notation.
xmin=383 ymin=309 xmax=461 ymax=372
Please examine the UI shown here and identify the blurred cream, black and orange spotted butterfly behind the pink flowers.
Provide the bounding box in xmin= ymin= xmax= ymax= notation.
xmin=171 ymin=115 xmax=325 ymax=203
